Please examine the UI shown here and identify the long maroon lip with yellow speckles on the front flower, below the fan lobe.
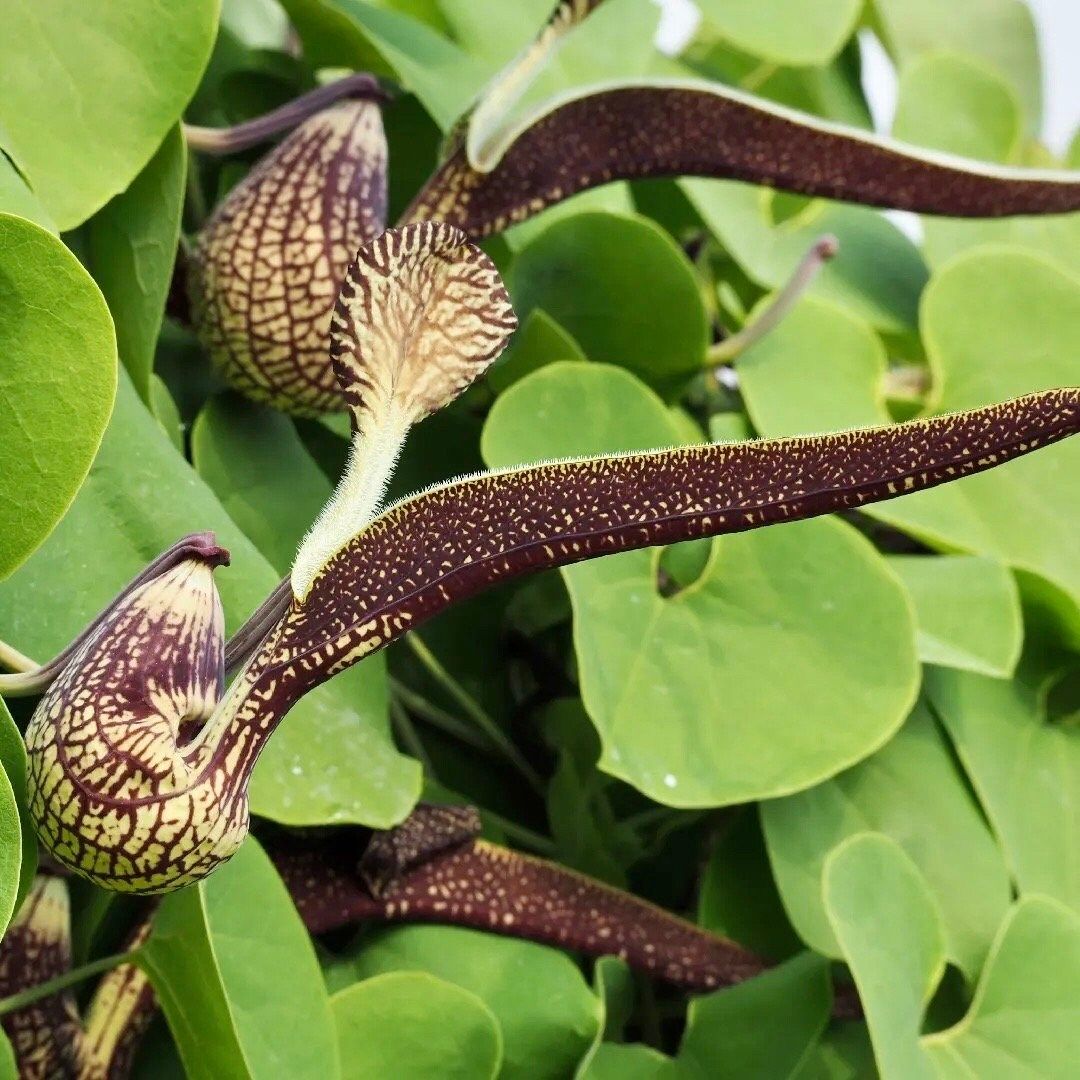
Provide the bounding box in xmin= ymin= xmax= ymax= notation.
xmin=249 ymin=389 xmax=1080 ymax=723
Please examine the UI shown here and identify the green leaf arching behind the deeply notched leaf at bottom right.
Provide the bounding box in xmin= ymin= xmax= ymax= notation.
xmin=761 ymin=706 xmax=1010 ymax=981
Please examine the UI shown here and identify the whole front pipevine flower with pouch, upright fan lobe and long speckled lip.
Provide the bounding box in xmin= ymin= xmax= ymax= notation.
xmin=0 ymin=222 xmax=1080 ymax=893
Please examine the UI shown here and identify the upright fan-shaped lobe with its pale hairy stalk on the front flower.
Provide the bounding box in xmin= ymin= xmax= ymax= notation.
xmin=292 ymin=222 xmax=517 ymax=597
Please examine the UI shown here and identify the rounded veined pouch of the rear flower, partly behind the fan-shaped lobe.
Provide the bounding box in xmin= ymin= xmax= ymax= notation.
xmin=189 ymin=85 xmax=387 ymax=415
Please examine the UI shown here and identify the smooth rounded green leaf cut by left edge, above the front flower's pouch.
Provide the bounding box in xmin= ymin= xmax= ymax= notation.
xmin=0 ymin=212 xmax=117 ymax=583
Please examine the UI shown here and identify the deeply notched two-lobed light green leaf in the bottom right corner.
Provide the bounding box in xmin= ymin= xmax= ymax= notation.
xmin=824 ymin=833 xmax=1080 ymax=1080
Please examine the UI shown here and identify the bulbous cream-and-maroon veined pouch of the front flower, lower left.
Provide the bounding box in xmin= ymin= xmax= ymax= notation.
xmin=26 ymin=535 xmax=247 ymax=892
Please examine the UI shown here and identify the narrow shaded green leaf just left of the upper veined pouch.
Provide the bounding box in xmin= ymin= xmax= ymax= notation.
xmin=87 ymin=127 xmax=187 ymax=402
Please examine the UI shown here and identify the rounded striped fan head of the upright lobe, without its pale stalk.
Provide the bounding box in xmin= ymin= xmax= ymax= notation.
xmin=330 ymin=222 xmax=517 ymax=435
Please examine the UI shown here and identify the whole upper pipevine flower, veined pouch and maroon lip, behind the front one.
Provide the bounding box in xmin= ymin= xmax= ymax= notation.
xmin=183 ymin=0 xmax=1080 ymax=415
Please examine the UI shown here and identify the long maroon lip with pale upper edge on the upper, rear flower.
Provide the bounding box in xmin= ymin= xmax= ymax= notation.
xmin=404 ymin=80 xmax=1080 ymax=238
